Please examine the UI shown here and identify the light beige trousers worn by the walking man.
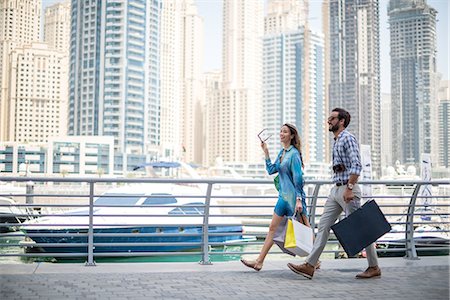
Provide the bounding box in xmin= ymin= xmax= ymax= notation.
xmin=306 ymin=184 xmax=378 ymax=267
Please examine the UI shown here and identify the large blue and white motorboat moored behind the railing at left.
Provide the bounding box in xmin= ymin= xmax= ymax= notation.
xmin=21 ymin=183 xmax=245 ymax=253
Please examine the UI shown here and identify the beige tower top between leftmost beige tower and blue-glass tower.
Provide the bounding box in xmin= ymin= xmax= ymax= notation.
xmin=44 ymin=0 xmax=70 ymax=53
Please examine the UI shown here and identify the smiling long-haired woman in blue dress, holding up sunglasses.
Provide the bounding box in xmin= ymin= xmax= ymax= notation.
xmin=241 ymin=124 xmax=310 ymax=271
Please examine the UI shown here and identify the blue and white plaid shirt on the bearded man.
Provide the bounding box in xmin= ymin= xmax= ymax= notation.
xmin=333 ymin=129 xmax=362 ymax=183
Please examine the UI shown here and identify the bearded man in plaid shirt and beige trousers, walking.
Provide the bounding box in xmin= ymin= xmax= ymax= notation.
xmin=288 ymin=108 xmax=381 ymax=279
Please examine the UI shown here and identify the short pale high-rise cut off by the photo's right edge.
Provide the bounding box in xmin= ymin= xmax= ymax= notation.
xmin=438 ymin=80 xmax=450 ymax=168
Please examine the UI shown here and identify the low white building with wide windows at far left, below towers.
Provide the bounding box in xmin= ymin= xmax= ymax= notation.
xmin=0 ymin=136 xmax=114 ymax=176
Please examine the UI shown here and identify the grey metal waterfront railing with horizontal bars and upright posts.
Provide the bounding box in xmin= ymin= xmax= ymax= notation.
xmin=0 ymin=176 xmax=450 ymax=266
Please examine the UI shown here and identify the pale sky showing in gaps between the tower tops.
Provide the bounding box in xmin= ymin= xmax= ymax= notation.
xmin=42 ymin=0 xmax=450 ymax=93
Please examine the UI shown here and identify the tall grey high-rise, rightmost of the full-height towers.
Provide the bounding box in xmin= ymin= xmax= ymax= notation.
xmin=388 ymin=0 xmax=438 ymax=164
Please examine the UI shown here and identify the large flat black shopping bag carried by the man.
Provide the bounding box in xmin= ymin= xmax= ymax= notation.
xmin=331 ymin=200 xmax=391 ymax=256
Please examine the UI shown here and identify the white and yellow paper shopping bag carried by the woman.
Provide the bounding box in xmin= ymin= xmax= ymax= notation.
xmin=284 ymin=219 xmax=313 ymax=256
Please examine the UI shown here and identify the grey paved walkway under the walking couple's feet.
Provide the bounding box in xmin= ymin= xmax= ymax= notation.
xmin=0 ymin=256 xmax=450 ymax=300
